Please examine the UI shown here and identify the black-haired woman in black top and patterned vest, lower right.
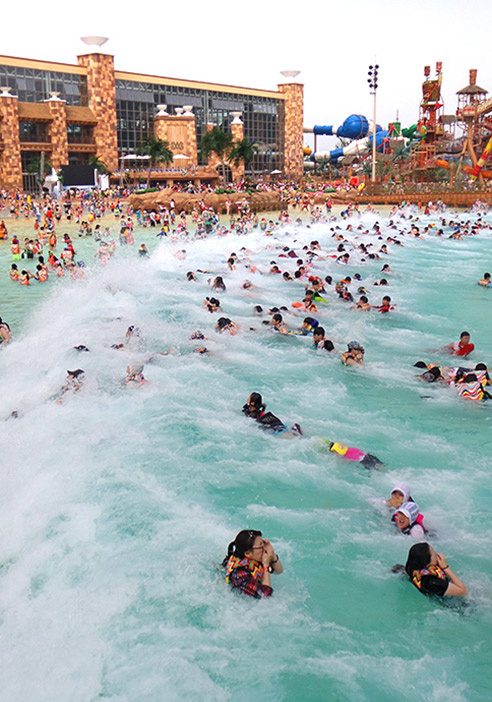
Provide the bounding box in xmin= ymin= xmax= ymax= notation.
xmin=405 ymin=542 xmax=468 ymax=597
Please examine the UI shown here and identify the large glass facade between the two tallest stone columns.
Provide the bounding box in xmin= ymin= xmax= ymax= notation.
xmin=116 ymin=80 xmax=282 ymax=171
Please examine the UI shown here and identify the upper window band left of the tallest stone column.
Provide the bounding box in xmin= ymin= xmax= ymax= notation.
xmin=0 ymin=65 xmax=87 ymax=106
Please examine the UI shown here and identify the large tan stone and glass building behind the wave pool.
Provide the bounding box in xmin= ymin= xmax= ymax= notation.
xmin=0 ymin=47 xmax=303 ymax=189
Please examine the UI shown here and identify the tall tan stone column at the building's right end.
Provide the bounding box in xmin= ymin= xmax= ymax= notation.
xmin=278 ymin=83 xmax=304 ymax=178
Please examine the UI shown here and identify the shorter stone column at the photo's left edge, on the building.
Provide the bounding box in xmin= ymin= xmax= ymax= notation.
xmin=0 ymin=88 xmax=22 ymax=190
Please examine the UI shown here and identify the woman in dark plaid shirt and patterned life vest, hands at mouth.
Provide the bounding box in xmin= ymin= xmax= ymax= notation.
xmin=222 ymin=529 xmax=284 ymax=599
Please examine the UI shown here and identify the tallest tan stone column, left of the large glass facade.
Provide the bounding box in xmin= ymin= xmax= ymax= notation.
xmin=77 ymin=53 xmax=118 ymax=170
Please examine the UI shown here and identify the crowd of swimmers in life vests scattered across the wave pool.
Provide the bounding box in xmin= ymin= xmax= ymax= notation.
xmin=0 ymin=192 xmax=490 ymax=597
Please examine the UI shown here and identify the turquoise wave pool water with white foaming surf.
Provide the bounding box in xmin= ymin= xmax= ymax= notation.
xmin=0 ymin=213 xmax=492 ymax=702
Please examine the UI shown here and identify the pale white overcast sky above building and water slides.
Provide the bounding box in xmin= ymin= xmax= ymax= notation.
xmin=0 ymin=0 xmax=492 ymax=153
